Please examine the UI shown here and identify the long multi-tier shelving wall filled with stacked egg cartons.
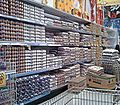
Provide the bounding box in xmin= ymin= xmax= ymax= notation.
xmin=0 ymin=0 xmax=114 ymax=105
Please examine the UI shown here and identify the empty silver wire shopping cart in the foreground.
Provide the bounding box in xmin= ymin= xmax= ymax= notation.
xmin=39 ymin=88 xmax=120 ymax=105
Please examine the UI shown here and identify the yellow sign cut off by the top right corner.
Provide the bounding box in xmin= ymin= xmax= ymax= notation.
xmin=97 ymin=0 xmax=120 ymax=6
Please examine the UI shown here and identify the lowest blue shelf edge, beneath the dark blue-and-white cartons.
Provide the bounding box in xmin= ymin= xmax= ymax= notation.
xmin=22 ymin=91 xmax=50 ymax=105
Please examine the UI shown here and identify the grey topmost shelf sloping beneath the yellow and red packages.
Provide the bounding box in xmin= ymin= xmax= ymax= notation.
xmin=22 ymin=0 xmax=91 ymax=24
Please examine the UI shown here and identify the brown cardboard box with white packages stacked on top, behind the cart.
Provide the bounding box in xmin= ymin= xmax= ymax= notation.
xmin=86 ymin=66 xmax=116 ymax=89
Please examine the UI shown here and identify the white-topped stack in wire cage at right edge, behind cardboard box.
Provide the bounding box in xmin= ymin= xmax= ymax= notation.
xmin=102 ymin=49 xmax=120 ymax=82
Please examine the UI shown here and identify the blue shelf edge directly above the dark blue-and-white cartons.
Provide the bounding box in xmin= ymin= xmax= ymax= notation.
xmin=16 ymin=66 xmax=62 ymax=78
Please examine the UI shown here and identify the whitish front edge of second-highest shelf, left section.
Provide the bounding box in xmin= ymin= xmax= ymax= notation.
xmin=0 ymin=14 xmax=44 ymax=26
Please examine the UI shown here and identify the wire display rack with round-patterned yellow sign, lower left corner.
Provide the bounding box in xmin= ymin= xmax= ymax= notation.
xmin=0 ymin=62 xmax=16 ymax=105
